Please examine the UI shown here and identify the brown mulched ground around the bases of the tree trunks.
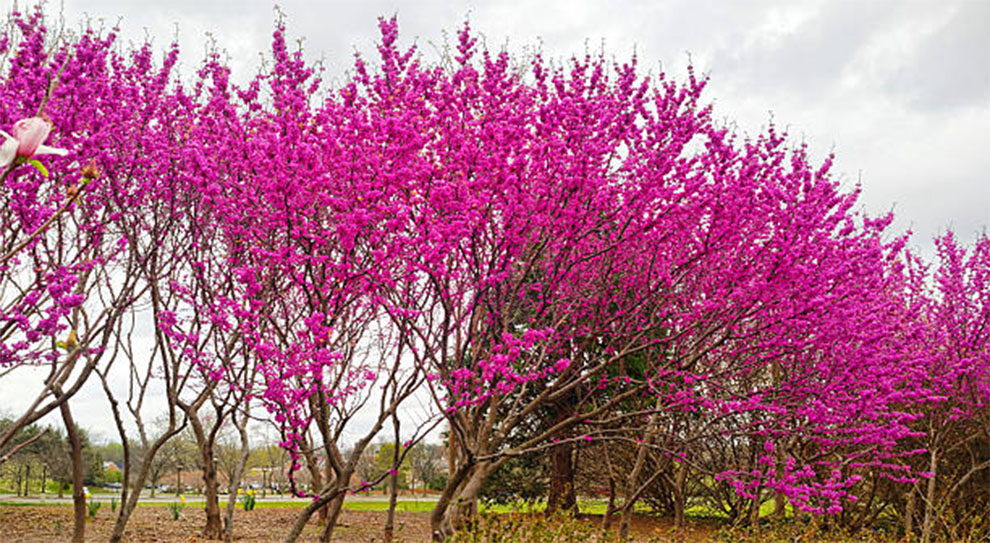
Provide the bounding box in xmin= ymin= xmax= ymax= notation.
xmin=0 ymin=506 xmax=713 ymax=543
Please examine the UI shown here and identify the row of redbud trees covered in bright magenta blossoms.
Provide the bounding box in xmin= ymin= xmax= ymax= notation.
xmin=0 ymin=5 xmax=990 ymax=540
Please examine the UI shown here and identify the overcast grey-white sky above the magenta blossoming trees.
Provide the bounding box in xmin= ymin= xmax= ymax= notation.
xmin=0 ymin=0 xmax=990 ymax=442
